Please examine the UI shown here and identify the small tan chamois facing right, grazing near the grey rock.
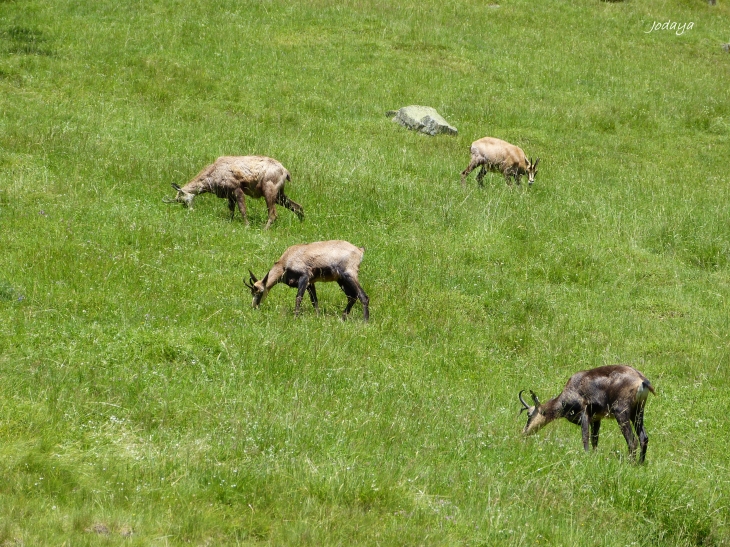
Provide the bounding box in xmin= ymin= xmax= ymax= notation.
xmin=461 ymin=137 xmax=540 ymax=186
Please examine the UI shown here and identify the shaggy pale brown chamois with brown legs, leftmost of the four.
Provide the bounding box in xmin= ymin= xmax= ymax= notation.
xmin=163 ymin=156 xmax=304 ymax=229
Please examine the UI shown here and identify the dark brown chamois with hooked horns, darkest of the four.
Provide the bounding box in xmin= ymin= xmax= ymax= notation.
xmin=519 ymin=365 xmax=654 ymax=463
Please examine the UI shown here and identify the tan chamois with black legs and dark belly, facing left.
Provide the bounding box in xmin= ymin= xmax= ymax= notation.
xmin=243 ymin=241 xmax=370 ymax=321
